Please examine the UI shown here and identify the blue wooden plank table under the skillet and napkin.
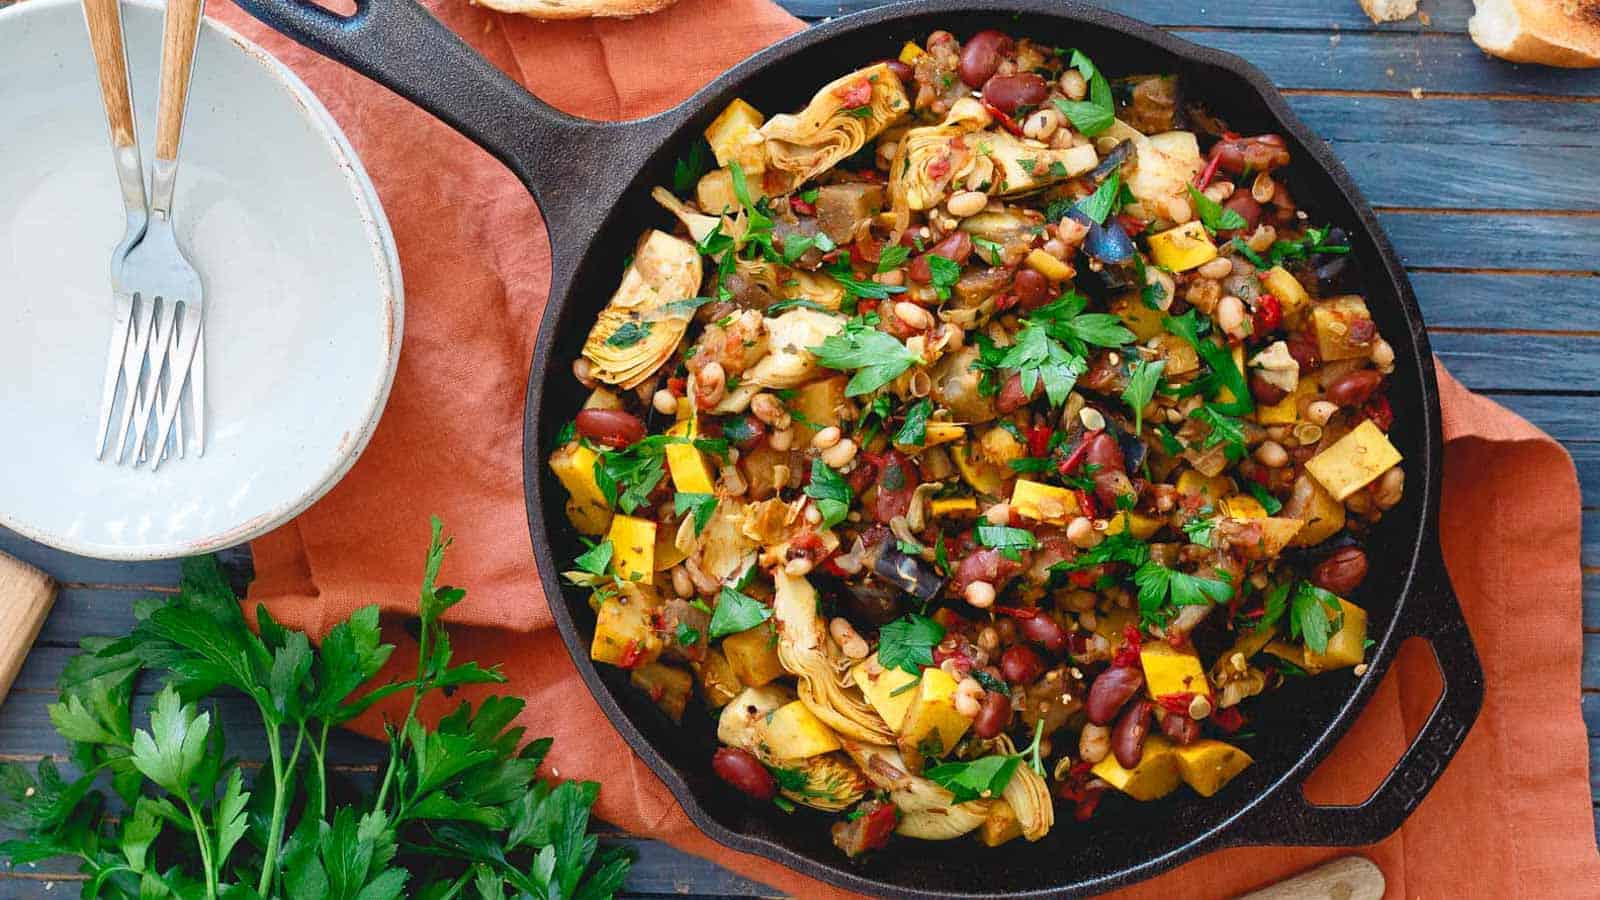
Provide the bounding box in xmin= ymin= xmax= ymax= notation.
xmin=0 ymin=0 xmax=1600 ymax=898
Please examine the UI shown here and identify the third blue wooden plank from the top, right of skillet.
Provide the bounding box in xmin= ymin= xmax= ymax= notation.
xmin=1290 ymin=94 xmax=1600 ymax=154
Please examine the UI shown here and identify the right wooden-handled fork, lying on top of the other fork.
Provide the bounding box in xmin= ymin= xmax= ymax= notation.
xmin=123 ymin=0 xmax=205 ymax=469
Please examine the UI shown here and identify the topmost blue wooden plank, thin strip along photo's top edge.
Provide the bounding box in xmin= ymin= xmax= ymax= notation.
xmin=778 ymin=0 xmax=1472 ymax=34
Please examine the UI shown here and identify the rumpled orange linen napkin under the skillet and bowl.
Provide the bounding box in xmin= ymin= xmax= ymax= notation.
xmin=213 ymin=0 xmax=1600 ymax=897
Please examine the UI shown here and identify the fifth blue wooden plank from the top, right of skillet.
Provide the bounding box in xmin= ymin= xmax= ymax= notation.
xmin=1378 ymin=211 xmax=1600 ymax=272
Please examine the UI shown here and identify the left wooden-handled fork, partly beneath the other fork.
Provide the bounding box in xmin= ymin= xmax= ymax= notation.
xmin=83 ymin=0 xmax=152 ymax=460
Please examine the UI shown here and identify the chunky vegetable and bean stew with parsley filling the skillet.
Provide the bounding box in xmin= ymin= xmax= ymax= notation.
xmin=549 ymin=30 xmax=1405 ymax=857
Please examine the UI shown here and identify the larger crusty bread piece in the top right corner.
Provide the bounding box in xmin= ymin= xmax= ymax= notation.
xmin=1467 ymin=0 xmax=1600 ymax=69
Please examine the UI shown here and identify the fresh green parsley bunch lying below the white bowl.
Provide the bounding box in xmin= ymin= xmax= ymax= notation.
xmin=0 ymin=519 xmax=630 ymax=900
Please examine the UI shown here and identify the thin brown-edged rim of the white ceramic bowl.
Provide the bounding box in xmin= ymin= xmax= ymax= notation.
xmin=0 ymin=0 xmax=405 ymax=562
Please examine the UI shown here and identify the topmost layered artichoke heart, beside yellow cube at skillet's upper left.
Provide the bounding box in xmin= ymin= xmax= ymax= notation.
xmin=762 ymin=62 xmax=910 ymax=192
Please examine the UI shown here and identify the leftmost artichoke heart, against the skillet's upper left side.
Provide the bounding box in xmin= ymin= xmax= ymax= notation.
xmin=584 ymin=229 xmax=701 ymax=389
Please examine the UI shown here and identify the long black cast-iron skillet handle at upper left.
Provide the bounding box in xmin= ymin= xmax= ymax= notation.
xmin=238 ymin=0 xmax=640 ymax=240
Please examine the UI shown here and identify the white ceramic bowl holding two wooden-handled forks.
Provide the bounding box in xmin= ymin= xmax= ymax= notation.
xmin=0 ymin=0 xmax=403 ymax=559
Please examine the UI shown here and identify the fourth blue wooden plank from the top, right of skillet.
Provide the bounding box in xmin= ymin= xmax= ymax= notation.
xmin=1331 ymin=140 xmax=1600 ymax=211
